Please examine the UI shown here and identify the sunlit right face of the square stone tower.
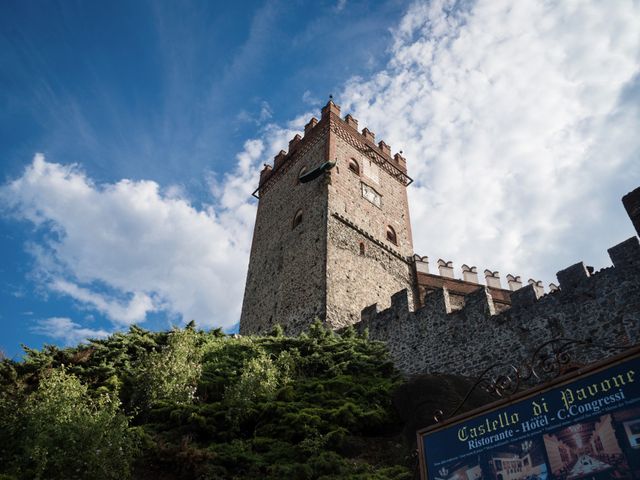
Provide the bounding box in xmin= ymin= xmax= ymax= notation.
xmin=327 ymin=113 xmax=413 ymax=328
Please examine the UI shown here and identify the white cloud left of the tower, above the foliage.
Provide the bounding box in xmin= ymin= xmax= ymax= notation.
xmin=0 ymin=156 xmax=255 ymax=327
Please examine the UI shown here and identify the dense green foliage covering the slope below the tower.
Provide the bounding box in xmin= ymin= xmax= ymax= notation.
xmin=0 ymin=323 xmax=411 ymax=480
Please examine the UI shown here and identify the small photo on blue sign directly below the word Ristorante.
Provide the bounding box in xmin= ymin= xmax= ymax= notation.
xmin=480 ymin=438 xmax=548 ymax=480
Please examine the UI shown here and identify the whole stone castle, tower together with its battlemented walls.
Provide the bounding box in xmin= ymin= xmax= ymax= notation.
xmin=240 ymin=101 xmax=640 ymax=376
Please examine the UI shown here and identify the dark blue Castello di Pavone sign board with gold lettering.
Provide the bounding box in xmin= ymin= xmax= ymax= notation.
xmin=418 ymin=349 xmax=640 ymax=480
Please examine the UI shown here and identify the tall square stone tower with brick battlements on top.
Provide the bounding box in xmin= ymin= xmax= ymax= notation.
xmin=240 ymin=101 xmax=414 ymax=334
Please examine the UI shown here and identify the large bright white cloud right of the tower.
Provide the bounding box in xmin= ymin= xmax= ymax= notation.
xmin=340 ymin=0 xmax=640 ymax=280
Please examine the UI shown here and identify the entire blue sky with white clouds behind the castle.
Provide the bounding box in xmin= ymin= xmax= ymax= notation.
xmin=0 ymin=0 xmax=640 ymax=356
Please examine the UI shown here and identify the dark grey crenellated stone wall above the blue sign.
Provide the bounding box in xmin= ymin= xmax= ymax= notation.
xmin=356 ymin=237 xmax=640 ymax=376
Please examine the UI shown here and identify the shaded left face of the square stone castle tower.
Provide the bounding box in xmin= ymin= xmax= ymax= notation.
xmin=240 ymin=131 xmax=327 ymax=335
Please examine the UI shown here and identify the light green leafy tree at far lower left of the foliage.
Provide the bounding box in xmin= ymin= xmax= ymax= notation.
xmin=14 ymin=368 xmax=135 ymax=479
